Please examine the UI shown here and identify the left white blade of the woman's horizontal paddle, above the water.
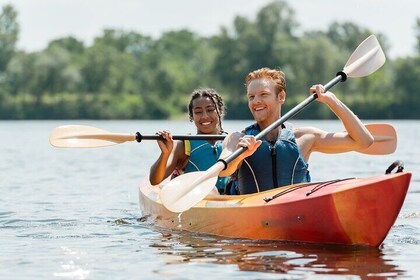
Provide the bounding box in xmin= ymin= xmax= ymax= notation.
xmin=49 ymin=125 xmax=136 ymax=148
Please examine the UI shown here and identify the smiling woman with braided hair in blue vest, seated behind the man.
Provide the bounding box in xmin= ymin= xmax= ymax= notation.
xmin=149 ymin=88 xmax=228 ymax=194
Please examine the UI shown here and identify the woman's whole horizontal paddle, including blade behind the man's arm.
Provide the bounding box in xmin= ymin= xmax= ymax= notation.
xmin=50 ymin=124 xmax=397 ymax=155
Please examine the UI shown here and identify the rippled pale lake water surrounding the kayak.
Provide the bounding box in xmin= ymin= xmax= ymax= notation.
xmin=0 ymin=120 xmax=420 ymax=279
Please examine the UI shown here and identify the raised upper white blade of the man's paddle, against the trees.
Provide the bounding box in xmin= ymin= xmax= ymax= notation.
xmin=343 ymin=35 xmax=386 ymax=78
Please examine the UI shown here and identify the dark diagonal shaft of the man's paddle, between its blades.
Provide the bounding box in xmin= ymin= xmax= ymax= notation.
xmin=219 ymin=71 xmax=347 ymax=169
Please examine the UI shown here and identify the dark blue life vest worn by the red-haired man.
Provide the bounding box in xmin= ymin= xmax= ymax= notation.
xmin=237 ymin=123 xmax=311 ymax=194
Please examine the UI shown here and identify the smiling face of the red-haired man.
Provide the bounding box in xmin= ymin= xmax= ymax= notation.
xmin=247 ymin=78 xmax=286 ymax=129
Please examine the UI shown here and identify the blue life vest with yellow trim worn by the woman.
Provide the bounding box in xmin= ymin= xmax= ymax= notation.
xmin=183 ymin=140 xmax=229 ymax=193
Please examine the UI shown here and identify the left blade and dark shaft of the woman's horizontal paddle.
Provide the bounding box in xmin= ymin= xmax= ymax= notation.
xmin=50 ymin=125 xmax=226 ymax=148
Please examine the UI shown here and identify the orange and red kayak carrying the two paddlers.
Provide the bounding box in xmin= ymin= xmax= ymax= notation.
xmin=139 ymin=172 xmax=412 ymax=247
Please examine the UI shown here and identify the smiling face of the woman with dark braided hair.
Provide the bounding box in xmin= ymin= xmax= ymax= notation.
xmin=192 ymin=97 xmax=220 ymax=134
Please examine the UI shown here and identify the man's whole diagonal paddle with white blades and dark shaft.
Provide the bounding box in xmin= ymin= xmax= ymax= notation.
xmin=160 ymin=35 xmax=385 ymax=212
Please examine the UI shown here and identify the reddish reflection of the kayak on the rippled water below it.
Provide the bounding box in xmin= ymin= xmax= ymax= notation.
xmin=144 ymin=226 xmax=405 ymax=279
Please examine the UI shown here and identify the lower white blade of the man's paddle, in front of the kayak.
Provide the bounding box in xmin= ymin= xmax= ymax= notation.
xmin=159 ymin=162 xmax=224 ymax=213
